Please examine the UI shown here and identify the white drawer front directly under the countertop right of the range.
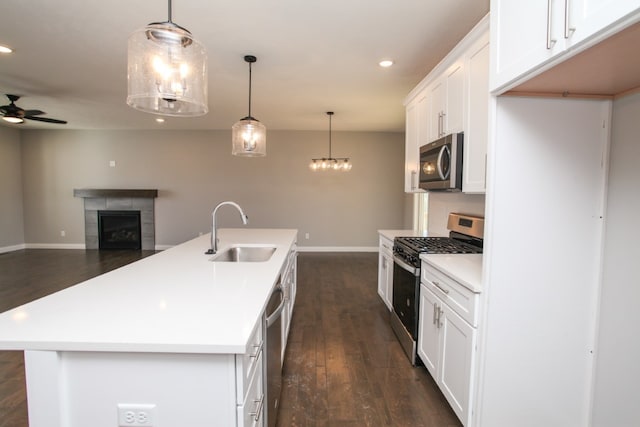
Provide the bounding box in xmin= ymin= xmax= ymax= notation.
xmin=420 ymin=262 xmax=480 ymax=327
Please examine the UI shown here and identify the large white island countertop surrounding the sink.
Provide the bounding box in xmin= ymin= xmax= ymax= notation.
xmin=0 ymin=228 xmax=297 ymax=353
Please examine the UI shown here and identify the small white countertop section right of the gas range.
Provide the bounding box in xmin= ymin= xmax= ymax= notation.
xmin=420 ymin=254 xmax=482 ymax=292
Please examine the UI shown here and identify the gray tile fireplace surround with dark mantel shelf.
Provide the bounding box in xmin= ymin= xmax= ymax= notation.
xmin=73 ymin=188 xmax=158 ymax=250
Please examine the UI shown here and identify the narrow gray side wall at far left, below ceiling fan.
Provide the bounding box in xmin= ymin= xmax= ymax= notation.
xmin=0 ymin=126 xmax=24 ymax=249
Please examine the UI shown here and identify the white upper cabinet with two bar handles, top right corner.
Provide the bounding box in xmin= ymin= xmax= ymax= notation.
xmin=490 ymin=0 xmax=640 ymax=93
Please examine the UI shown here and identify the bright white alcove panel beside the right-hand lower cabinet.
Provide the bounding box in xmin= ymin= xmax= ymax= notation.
xmin=476 ymin=97 xmax=612 ymax=427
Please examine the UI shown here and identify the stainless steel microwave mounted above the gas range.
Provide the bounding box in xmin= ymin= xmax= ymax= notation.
xmin=420 ymin=132 xmax=463 ymax=191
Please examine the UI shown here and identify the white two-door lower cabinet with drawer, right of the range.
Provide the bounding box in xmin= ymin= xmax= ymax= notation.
xmin=418 ymin=262 xmax=478 ymax=426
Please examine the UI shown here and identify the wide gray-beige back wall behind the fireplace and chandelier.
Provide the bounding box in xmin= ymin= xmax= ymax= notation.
xmin=13 ymin=130 xmax=407 ymax=248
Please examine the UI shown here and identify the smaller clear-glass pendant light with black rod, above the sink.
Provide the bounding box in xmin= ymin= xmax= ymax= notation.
xmin=231 ymin=55 xmax=267 ymax=157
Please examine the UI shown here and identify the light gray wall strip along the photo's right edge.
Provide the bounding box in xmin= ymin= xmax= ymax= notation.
xmin=593 ymin=94 xmax=640 ymax=427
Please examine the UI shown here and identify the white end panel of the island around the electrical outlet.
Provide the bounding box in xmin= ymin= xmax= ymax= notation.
xmin=25 ymin=351 xmax=236 ymax=427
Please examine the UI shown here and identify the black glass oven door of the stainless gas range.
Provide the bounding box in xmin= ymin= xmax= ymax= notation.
xmin=393 ymin=256 xmax=420 ymax=341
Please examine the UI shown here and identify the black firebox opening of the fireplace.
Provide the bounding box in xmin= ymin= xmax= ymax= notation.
xmin=98 ymin=211 xmax=142 ymax=249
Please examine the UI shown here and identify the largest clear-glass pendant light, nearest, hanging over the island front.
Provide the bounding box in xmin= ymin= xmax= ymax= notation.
xmin=127 ymin=0 xmax=209 ymax=117
